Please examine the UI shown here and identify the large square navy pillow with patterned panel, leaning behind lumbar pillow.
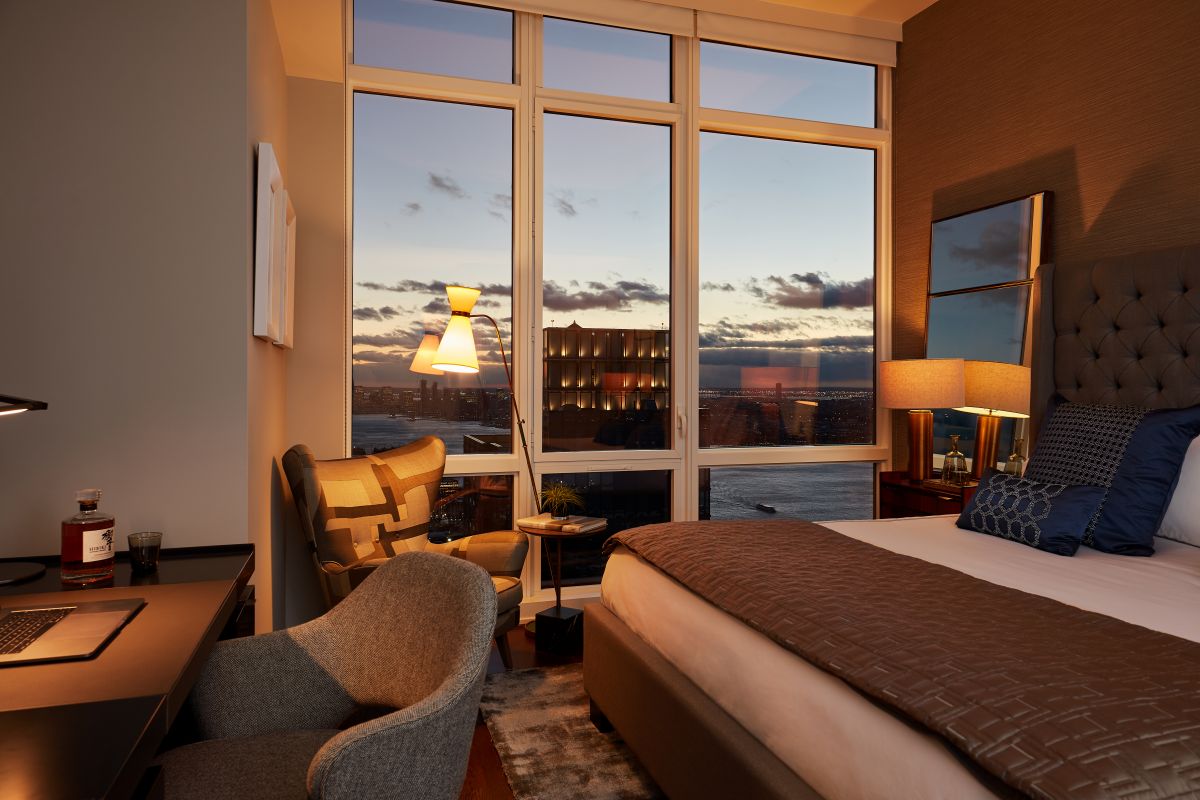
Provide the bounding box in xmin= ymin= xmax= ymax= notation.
xmin=1025 ymin=403 xmax=1200 ymax=555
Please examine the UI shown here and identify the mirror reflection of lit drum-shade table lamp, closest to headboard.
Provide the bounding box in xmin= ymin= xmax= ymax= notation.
xmin=953 ymin=361 xmax=1030 ymax=480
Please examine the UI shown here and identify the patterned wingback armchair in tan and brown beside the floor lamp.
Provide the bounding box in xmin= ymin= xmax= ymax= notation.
xmin=283 ymin=437 xmax=529 ymax=668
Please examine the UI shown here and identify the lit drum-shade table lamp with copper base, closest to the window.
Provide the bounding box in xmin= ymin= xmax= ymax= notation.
xmin=880 ymin=359 xmax=966 ymax=481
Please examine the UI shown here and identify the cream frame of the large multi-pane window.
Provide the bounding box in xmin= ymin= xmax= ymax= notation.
xmin=343 ymin=0 xmax=893 ymax=613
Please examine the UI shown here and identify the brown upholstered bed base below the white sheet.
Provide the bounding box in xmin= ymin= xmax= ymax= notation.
xmin=583 ymin=603 xmax=821 ymax=800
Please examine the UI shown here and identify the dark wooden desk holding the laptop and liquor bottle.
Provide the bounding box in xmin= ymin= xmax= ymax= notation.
xmin=0 ymin=545 xmax=254 ymax=800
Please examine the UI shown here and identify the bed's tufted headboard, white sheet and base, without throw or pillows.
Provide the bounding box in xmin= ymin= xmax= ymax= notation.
xmin=584 ymin=248 xmax=1200 ymax=800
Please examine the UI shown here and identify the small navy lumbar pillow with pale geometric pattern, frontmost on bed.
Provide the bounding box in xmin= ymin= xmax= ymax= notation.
xmin=958 ymin=469 xmax=1104 ymax=555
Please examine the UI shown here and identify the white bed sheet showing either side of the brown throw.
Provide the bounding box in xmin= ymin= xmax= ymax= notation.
xmin=600 ymin=517 xmax=1200 ymax=800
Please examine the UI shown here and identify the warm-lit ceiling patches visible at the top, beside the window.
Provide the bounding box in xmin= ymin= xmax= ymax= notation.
xmin=271 ymin=0 xmax=936 ymax=83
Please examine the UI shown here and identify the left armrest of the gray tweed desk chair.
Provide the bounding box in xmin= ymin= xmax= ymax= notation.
xmin=191 ymin=619 xmax=355 ymax=739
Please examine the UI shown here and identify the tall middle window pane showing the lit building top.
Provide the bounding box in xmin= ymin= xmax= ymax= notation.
xmin=542 ymin=114 xmax=671 ymax=452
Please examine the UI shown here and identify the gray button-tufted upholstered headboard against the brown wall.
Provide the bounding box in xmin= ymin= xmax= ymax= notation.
xmin=1030 ymin=246 xmax=1200 ymax=441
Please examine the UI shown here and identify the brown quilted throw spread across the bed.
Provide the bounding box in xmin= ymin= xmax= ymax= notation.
xmin=606 ymin=521 xmax=1200 ymax=799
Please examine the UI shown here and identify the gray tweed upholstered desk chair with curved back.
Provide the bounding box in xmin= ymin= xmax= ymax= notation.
xmin=161 ymin=553 xmax=496 ymax=800
